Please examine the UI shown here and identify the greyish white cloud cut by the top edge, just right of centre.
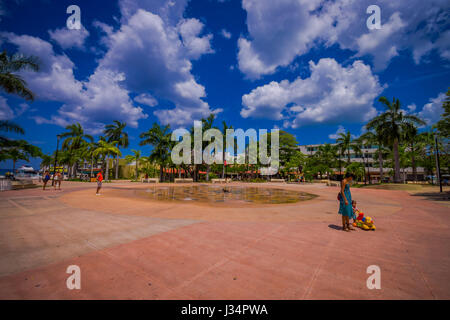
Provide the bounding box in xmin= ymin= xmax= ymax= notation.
xmin=238 ymin=0 xmax=328 ymax=79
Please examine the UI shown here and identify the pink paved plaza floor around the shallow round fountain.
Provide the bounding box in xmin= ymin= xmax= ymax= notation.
xmin=0 ymin=182 xmax=450 ymax=299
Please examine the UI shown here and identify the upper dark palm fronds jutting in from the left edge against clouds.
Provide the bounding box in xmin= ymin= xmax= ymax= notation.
xmin=0 ymin=51 xmax=39 ymax=101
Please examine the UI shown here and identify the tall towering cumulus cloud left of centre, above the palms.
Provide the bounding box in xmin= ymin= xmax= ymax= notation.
xmin=100 ymin=5 xmax=219 ymax=125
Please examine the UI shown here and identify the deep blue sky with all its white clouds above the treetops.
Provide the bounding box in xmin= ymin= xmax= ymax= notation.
xmin=0 ymin=0 xmax=450 ymax=168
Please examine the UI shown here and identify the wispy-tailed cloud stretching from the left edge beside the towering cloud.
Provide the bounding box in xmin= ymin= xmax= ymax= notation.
xmin=2 ymin=33 xmax=147 ymax=133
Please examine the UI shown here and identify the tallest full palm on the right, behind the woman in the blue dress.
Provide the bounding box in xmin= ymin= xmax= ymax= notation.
xmin=366 ymin=97 xmax=425 ymax=183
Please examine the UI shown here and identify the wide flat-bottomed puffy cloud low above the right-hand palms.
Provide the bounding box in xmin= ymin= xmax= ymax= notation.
xmin=241 ymin=58 xmax=383 ymax=128
